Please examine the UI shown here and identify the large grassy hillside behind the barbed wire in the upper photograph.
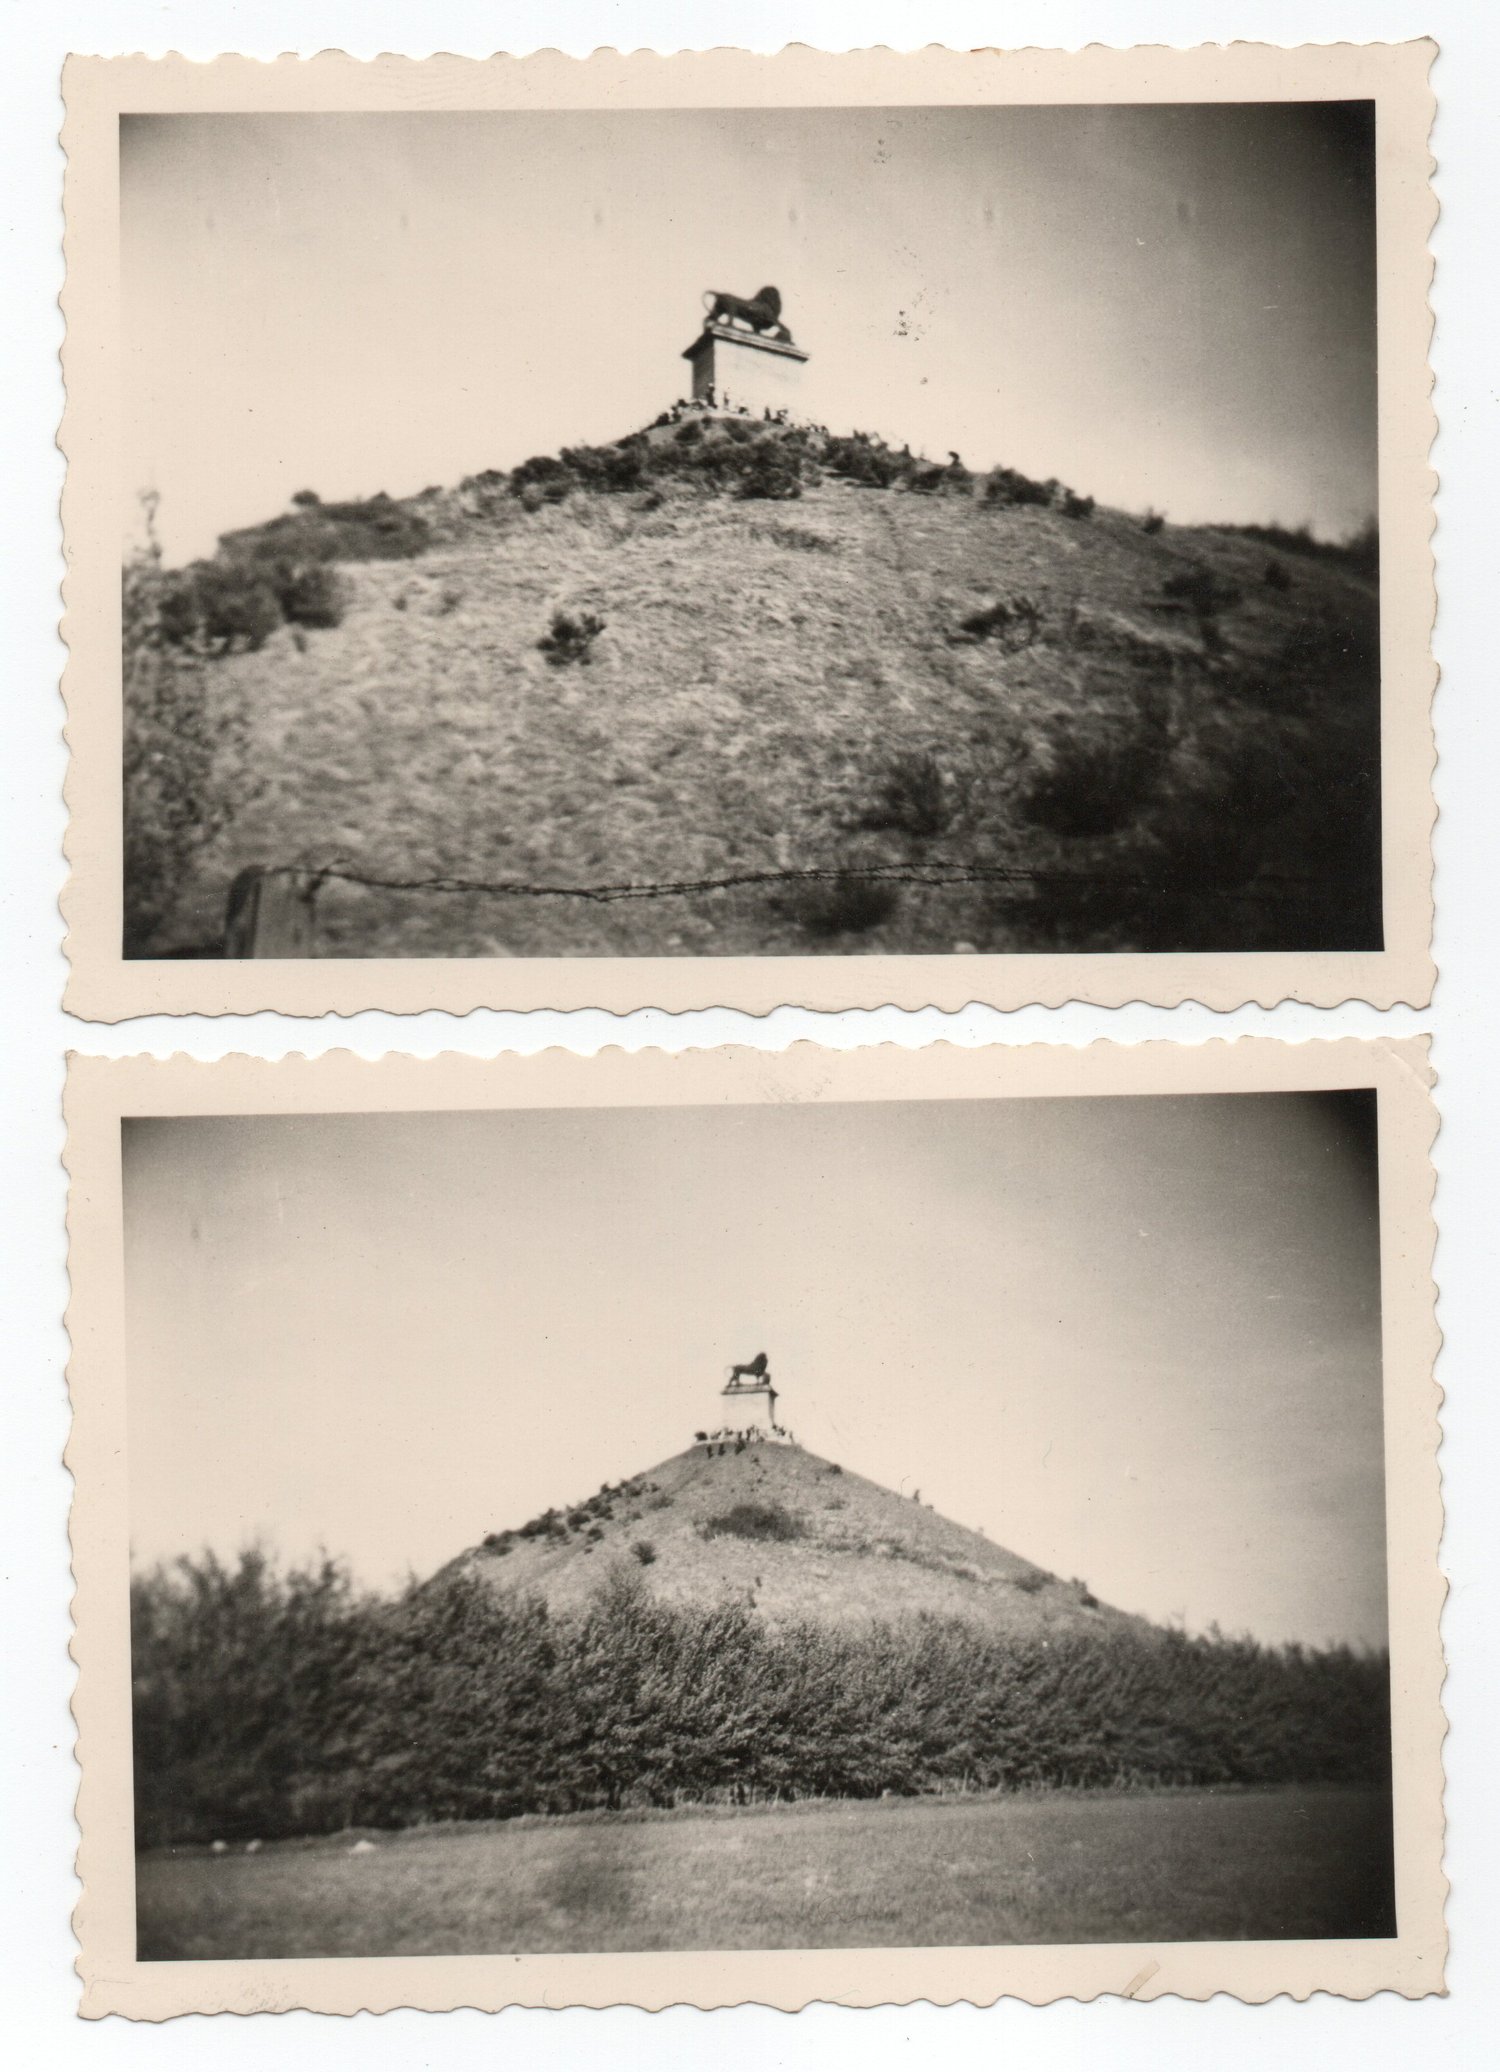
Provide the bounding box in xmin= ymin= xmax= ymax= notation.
xmin=155 ymin=429 xmax=1380 ymax=955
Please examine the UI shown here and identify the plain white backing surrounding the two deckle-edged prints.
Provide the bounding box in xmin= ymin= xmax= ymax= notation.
xmin=0 ymin=0 xmax=1500 ymax=2072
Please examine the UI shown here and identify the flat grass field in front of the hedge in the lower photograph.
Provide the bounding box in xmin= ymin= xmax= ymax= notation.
xmin=137 ymin=1788 xmax=1394 ymax=1960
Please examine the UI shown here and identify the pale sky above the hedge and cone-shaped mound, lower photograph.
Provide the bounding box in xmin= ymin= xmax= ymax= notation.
xmin=124 ymin=1094 xmax=1386 ymax=1645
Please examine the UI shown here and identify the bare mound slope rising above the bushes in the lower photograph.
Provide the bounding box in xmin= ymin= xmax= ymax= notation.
xmin=450 ymin=1444 xmax=1135 ymax=1633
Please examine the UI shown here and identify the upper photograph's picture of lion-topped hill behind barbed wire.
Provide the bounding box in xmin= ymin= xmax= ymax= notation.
xmin=61 ymin=48 xmax=1430 ymax=1005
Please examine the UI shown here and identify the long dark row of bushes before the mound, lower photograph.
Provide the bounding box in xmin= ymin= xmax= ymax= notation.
xmin=131 ymin=1554 xmax=1388 ymax=1846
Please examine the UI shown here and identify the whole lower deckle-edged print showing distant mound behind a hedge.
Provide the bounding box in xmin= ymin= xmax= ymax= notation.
xmin=70 ymin=1044 xmax=1442 ymax=2012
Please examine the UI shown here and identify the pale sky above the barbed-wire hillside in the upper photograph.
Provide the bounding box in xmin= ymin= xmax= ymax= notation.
xmin=120 ymin=104 xmax=1376 ymax=562
